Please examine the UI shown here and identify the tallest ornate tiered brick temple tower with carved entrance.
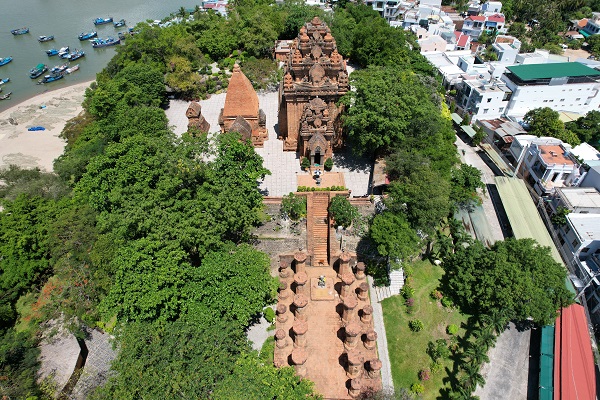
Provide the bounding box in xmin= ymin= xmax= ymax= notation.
xmin=279 ymin=17 xmax=350 ymax=165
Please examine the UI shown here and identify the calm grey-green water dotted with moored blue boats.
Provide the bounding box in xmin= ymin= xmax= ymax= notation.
xmin=0 ymin=0 xmax=201 ymax=111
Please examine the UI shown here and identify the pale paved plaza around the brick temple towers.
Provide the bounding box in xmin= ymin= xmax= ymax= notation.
xmin=165 ymin=92 xmax=371 ymax=197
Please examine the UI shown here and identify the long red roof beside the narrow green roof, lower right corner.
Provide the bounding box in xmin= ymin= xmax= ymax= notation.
xmin=554 ymin=304 xmax=596 ymax=400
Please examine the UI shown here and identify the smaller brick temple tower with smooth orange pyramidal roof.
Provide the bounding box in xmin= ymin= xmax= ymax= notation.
xmin=219 ymin=64 xmax=268 ymax=147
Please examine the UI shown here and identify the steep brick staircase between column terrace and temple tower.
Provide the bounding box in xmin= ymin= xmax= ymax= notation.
xmin=308 ymin=192 xmax=329 ymax=266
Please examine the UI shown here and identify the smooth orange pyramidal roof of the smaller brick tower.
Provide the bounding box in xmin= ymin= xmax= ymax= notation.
xmin=223 ymin=64 xmax=258 ymax=118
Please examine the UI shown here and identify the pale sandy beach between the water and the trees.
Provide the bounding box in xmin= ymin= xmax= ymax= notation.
xmin=0 ymin=81 xmax=93 ymax=171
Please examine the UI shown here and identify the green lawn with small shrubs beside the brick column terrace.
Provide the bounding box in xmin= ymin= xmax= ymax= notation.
xmin=381 ymin=261 xmax=467 ymax=399
